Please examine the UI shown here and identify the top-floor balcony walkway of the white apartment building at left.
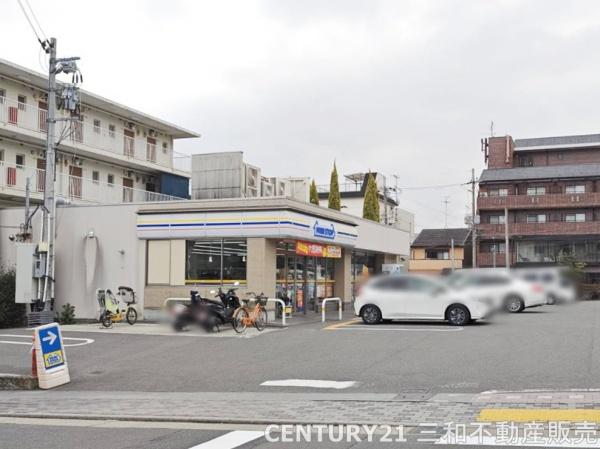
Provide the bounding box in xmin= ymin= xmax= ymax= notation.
xmin=0 ymin=97 xmax=191 ymax=175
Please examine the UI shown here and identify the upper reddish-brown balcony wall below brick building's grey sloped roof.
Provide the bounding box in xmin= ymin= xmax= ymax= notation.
xmin=477 ymin=192 xmax=600 ymax=210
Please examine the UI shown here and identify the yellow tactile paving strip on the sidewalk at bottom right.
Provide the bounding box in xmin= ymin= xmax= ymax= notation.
xmin=477 ymin=408 xmax=600 ymax=423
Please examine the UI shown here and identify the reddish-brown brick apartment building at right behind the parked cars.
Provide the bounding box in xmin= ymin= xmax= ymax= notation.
xmin=477 ymin=134 xmax=600 ymax=282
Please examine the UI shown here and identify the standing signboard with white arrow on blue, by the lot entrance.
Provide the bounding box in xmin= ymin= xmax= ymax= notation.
xmin=33 ymin=323 xmax=71 ymax=389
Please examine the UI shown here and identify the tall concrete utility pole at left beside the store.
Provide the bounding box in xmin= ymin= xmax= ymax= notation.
xmin=42 ymin=38 xmax=56 ymax=310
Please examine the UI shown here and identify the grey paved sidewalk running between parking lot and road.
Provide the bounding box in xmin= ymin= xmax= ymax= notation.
xmin=0 ymin=390 xmax=600 ymax=426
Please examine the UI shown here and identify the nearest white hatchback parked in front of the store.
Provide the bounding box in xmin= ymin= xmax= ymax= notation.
xmin=354 ymin=274 xmax=493 ymax=326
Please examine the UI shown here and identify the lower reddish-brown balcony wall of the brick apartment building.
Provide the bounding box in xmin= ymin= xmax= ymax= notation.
xmin=477 ymin=221 xmax=600 ymax=239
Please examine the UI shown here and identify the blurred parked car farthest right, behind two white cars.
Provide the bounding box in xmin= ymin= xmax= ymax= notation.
xmin=515 ymin=267 xmax=577 ymax=304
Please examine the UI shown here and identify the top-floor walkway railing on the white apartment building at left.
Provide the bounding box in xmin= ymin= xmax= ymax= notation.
xmin=0 ymin=97 xmax=191 ymax=171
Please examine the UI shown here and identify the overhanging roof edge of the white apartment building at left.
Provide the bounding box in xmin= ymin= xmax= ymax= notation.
xmin=0 ymin=58 xmax=200 ymax=139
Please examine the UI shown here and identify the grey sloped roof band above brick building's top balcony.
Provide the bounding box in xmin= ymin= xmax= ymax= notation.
xmin=479 ymin=164 xmax=600 ymax=182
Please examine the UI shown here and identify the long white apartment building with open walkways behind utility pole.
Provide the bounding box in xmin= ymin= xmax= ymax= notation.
xmin=0 ymin=59 xmax=199 ymax=207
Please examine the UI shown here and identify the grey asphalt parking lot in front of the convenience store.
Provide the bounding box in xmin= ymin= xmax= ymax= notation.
xmin=0 ymin=301 xmax=600 ymax=393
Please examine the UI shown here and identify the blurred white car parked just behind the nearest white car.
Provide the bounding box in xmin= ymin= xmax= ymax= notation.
xmin=446 ymin=268 xmax=546 ymax=313
